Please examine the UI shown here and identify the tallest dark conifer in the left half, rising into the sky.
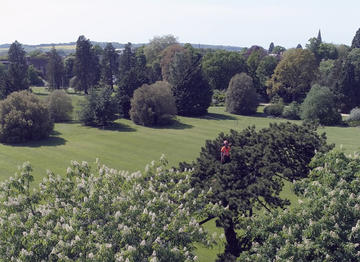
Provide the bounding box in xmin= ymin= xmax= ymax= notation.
xmin=75 ymin=35 xmax=100 ymax=94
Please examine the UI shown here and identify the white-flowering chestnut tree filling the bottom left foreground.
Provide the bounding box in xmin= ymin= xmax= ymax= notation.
xmin=0 ymin=157 xmax=220 ymax=262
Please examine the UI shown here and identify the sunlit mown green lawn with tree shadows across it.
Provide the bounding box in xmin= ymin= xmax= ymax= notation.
xmin=0 ymin=89 xmax=360 ymax=261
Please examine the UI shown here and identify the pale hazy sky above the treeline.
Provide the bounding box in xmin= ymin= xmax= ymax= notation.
xmin=0 ymin=0 xmax=360 ymax=48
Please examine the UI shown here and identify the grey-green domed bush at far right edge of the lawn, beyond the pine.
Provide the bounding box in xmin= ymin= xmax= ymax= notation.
xmin=301 ymin=85 xmax=341 ymax=125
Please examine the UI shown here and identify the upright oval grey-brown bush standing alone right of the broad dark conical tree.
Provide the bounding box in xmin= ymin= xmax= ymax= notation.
xmin=225 ymin=73 xmax=259 ymax=115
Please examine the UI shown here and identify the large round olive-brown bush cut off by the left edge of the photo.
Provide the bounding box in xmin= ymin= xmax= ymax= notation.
xmin=0 ymin=91 xmax=54 ymax=143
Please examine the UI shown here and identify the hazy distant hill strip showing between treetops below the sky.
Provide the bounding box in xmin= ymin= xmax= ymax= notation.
xmin=0 ymin=41 xmax=243 ymax=56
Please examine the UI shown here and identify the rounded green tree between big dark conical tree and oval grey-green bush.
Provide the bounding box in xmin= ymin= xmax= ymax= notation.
xmin=201 ymin=50 xmax=246 ymax=90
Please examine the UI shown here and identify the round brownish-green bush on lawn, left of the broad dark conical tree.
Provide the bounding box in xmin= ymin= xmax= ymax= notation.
xmin=130 ymin=81 xmax=176 ymax=126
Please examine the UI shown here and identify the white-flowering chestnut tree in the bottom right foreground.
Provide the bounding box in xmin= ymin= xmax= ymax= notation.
xmin=239 ymin=152 xmax=360 ymax=261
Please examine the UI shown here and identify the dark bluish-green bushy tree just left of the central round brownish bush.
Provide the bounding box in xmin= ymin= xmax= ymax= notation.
xmin=79 ymin=87 xmax=117 ymax=126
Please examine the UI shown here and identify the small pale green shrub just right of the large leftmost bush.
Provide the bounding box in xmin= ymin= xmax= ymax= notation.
xmin=47 ymin=90 xmax=73 ymax=122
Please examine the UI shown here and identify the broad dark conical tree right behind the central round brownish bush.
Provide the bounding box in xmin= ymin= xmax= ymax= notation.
xmin=165 ymin=45 xmax=212 ymax=116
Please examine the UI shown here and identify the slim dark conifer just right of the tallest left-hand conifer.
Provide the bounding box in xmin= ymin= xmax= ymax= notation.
xmin=101 ymin=43 xmax=119 ymax=88
